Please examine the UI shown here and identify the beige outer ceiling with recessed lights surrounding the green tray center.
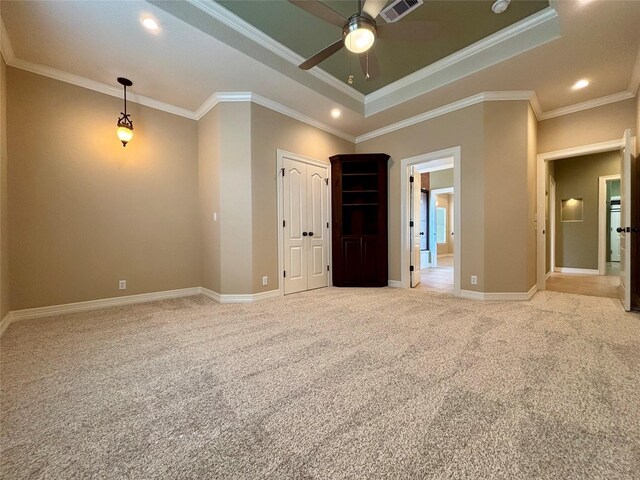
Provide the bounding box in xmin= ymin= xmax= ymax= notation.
xmin=0 ymin=0 xmax=640 ymax=138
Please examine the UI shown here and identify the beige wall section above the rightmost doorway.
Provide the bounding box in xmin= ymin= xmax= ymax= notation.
xmin=538 ymin=98 xmax=637 ymax=153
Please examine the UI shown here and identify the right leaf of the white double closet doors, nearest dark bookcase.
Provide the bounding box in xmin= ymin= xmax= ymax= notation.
xmin=307 ymin=165 xmax=329 ymax=290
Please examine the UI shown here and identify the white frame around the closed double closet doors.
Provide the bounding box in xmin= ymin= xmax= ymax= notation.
xmin=275 ymin=148 xmax=333 ymax=296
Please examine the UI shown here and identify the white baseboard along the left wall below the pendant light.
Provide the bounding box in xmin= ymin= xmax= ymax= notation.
xmin=11 ymin=287 xmax=200 ymax=323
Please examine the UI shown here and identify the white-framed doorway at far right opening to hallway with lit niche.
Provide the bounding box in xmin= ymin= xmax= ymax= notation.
xmin=537 ymin=131 xmax=632 ymax=303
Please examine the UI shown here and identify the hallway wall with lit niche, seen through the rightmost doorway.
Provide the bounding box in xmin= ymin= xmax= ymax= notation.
xmin=553 ymin=152 xmax=620 ymax=269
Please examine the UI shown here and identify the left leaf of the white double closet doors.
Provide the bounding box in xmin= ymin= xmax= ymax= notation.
xmin=282 ymin=158 xmax=308 ymax=294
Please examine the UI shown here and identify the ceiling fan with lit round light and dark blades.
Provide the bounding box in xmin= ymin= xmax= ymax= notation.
xmin=289 ymin=0 xmax=438 ymax=80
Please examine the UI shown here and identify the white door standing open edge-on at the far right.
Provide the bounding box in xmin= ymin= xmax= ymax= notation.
xmin=620 ymin=129 xmax=631 ymax=311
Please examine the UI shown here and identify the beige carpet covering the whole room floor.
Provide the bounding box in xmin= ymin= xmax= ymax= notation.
xmin=0 ymin=288 xmax=640 ymax=480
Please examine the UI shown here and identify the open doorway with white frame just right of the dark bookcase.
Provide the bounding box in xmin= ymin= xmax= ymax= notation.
xmin=400 ymin=147 xmax=461 ymax=296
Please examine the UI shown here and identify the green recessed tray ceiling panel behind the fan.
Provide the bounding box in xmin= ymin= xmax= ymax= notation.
xmin=219 ymin=0 xmax=549 ymax=94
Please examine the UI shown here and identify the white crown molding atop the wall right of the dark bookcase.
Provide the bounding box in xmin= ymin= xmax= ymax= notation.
xmin=356 ymin=90 xmax=537 ymax=143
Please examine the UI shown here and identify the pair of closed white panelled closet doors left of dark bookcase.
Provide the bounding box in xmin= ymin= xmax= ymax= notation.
xmin=282 ymin=157 xmax=329 ymax=294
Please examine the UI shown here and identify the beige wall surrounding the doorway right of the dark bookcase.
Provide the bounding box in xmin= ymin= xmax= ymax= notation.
xmin=356 ymin=104 xmax=484 ymax=291
